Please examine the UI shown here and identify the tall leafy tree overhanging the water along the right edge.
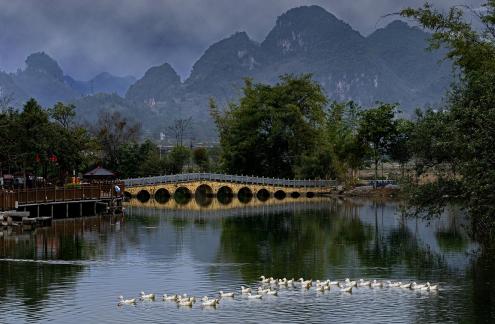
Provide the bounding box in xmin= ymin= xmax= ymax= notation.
xmin=401 ymin=0 xmax=495 ymax=237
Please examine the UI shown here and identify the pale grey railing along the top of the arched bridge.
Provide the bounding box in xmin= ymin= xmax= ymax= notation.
xmin=124 ymin=173 xmax=337 ymax=188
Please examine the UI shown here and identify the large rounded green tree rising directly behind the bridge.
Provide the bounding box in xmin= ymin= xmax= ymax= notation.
xmin=210 ymin=75 xmax=327 ymax=178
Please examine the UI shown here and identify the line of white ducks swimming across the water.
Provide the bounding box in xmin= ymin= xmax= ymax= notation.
xmin=117 ymin=276 xmax=438 ymax=307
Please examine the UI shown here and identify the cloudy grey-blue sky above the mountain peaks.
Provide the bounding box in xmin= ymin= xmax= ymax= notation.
xmin=0 ymin=0 xmax=484 ymax=79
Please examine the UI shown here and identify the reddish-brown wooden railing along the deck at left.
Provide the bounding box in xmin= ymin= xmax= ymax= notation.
xmin=0 ymin=183 xmax=124 ymax=210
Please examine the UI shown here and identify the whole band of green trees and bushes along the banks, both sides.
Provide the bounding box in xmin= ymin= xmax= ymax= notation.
xmin=0 ymin=0 xmax=495 ymax=242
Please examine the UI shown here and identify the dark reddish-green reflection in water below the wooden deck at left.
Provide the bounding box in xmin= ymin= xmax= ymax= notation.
xmin=0 ymin=217 xmax=125 ymax=316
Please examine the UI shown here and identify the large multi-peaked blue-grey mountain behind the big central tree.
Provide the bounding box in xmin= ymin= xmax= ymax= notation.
xmin=126 ymin=6 xmax=451 ymax=137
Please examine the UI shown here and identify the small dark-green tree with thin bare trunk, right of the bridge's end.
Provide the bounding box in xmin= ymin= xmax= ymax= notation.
xmin=358 ymin=103 xmax=397 ymax=179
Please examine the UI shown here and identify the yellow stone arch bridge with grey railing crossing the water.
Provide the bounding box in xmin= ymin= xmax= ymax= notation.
xmin=124 ymin=173 xmax=336 ymax=200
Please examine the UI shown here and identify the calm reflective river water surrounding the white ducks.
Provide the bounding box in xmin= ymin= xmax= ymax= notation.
xmin=0 ymin=198 xmax=495 ymax=323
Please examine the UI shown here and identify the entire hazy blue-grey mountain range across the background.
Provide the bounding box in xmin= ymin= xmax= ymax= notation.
xmin=0 ymin=6 xmax=451 ymax=139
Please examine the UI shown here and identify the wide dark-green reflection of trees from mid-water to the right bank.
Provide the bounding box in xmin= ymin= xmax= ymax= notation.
xmin=219 ymin=201 xmax=462 ymax=280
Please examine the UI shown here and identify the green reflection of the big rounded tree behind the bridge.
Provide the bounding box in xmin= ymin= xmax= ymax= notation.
xmin=215 ymin=204 xmax=370 ymax=280
